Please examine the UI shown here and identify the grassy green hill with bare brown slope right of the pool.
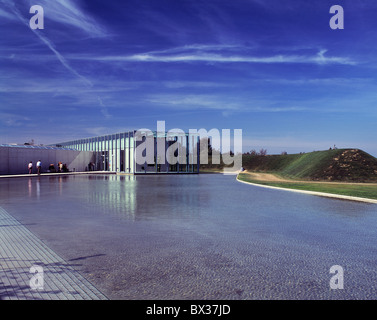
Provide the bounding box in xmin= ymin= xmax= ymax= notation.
xmin=242 ymin=149 xmax=377 ymax=182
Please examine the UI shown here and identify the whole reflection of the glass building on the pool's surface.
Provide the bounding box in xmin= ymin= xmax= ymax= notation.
xmin=81 ymin=175 xmax=204 ymax=220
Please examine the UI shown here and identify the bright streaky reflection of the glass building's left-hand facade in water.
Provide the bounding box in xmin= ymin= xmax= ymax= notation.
xmin=83 ymin=175 xmax=136 ymax=220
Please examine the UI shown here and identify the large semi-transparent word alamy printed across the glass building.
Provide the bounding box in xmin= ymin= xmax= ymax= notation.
xmin=135 ymin=121 xmax=242 ymax=173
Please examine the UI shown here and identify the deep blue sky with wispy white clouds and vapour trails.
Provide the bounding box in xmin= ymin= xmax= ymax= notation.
xmin=0 ymin=0 xmax=377 ymax=156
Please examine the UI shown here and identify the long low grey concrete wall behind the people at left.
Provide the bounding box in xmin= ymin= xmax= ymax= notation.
xmin=0 ymin=146 xmax=95 ymax=174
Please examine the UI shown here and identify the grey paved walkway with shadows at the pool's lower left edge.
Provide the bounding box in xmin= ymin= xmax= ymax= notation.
xmin=0 ymin=207 xmax=107 ymax=300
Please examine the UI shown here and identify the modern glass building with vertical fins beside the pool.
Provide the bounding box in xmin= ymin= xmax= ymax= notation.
xmin=55 ymin=130 xmax=200 ymax=174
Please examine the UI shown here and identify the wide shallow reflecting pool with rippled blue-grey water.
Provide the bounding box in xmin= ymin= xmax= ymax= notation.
xmin=0 ymin=174 xmax=377 ymax=300
